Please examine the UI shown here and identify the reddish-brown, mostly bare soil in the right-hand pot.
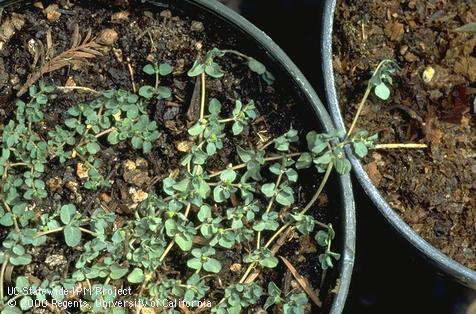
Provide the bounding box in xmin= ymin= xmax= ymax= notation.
xmin=333 ymin=0 xmax=476 ymax=270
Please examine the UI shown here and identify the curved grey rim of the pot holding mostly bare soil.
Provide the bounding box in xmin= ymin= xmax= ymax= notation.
xmin=321 ymin=0 xmax=476 ymax=289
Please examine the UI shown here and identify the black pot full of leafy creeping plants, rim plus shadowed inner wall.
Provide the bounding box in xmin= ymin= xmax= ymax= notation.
xmin=0 ymin=0 xmax=355 ymax=314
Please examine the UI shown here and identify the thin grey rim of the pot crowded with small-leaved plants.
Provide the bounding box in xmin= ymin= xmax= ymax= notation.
xmin=174 ymin=0 xmax=356 ymax=314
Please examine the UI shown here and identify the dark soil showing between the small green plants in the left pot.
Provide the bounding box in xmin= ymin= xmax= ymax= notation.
xmin=0 ymin=0 xmax=341 ymax=313
